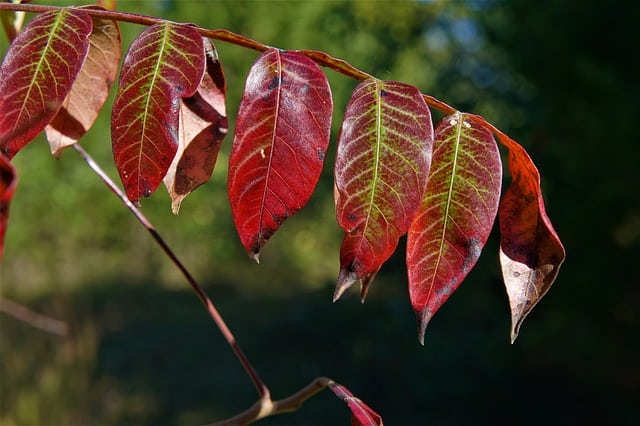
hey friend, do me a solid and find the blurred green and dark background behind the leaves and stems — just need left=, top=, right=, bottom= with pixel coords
left=0, top=0, right=640, bottom=425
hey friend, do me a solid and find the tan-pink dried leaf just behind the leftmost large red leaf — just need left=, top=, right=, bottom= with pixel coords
left=45, top=6, right=121, bottom=157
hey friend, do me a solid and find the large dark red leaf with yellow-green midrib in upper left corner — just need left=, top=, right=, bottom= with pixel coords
left=0, top=9, right=92, bottom=159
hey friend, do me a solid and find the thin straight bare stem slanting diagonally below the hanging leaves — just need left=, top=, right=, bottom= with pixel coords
left=73, top=143, right=271, bottom=400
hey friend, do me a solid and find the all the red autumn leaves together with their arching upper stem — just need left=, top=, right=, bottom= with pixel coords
left=0, top=2, right=565, bottom=424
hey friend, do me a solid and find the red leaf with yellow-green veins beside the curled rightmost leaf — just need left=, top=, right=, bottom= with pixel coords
left=407, top=112, right=502, bottom=344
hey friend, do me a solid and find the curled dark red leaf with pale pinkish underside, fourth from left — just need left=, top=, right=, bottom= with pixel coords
left=164, top=38, right=228, bottom=214
